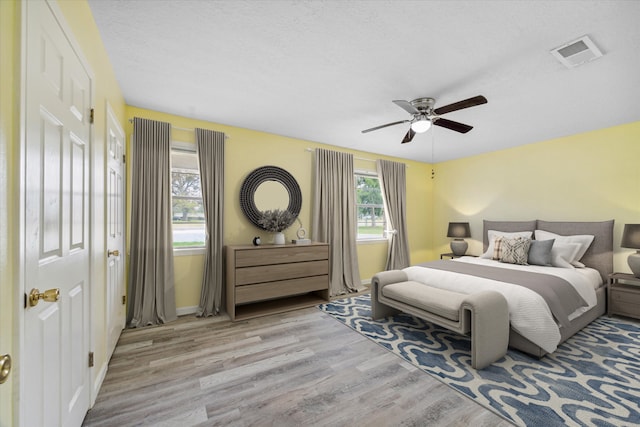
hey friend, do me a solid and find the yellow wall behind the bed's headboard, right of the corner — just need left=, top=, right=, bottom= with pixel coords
left=433, top=122, right=640, bottom=272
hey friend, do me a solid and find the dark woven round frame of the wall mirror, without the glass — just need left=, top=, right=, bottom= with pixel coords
left=240, top=166, right=302, bottom=230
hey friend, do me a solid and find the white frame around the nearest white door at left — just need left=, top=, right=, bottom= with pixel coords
left=17, top=0, right=96, bottom=427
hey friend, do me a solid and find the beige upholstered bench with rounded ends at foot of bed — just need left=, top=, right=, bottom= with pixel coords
left=371, top=270, right=509, bottom=369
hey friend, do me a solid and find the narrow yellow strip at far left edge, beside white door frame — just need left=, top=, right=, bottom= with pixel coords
left=0, top=1, right=20, bottom=427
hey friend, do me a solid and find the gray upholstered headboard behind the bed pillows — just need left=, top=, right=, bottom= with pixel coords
left=482, top=219, right=614, bottom=283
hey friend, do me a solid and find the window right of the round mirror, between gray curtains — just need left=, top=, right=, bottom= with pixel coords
left=355, top=172, right=386, bottom=240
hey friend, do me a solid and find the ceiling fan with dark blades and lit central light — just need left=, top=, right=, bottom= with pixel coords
left=362, top=95, right=487, bottom=144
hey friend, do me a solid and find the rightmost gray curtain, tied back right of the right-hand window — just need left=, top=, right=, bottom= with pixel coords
left=376, top=160, right=410, bottom=270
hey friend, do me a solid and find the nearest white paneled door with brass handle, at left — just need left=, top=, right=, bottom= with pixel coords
left=20, top=1, right=92, bottom=427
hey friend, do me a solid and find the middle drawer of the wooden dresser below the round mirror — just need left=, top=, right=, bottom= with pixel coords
left=236, top=260, right=329, bottom=286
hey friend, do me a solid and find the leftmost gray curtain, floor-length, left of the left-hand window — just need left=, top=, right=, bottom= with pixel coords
left=127, top=117, right=176, bottom=327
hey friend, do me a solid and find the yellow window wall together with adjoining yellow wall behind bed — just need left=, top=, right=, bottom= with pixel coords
left=127, top=107, right=640, bottom=308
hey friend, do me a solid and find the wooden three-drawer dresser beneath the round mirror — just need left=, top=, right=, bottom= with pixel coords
left=225, top=243, right=329, bottom=321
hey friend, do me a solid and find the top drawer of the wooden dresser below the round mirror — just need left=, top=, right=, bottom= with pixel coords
left=235, top=245, right=329, bottom=268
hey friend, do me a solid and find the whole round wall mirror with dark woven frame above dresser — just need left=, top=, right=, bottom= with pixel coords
left=240, top=166, right=302, bottom=230
